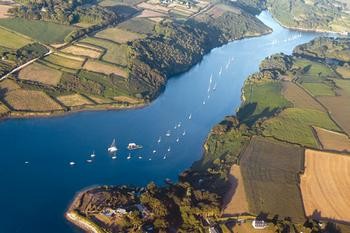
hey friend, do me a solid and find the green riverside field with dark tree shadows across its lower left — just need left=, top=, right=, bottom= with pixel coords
left=237, top=81, right=292, bottom=125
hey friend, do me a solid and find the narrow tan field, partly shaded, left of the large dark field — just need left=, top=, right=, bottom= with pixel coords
left=223, top=164, right=249, bottom=216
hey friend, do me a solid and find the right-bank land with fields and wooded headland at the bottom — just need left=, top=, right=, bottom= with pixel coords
left=67, top=38, right=350, bottom=232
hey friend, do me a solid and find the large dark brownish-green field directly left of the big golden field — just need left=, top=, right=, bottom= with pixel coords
left=240, top=137, right=304, bottom=222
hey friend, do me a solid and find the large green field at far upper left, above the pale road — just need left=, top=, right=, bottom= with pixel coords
left=0, top=18, right=74, bottom=44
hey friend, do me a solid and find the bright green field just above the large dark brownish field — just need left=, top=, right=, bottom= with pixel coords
left=263, top=108, right=340, bottom=148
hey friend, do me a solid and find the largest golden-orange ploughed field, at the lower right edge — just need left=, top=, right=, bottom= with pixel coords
left=300, top=150, right=350, bottom=223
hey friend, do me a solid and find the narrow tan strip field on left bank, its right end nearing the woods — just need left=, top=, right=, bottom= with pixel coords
left=83, top=60, right=128, bottom=78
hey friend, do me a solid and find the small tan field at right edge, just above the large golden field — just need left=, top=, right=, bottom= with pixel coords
left=314, top=127, right=350, bottom=152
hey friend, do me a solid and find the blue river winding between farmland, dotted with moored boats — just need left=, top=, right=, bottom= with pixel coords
left=0, top=13, right=319, bottom=233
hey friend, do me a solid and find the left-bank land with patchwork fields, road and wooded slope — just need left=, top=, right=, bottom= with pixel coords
left=0, top=0, right=271, bottom=117
